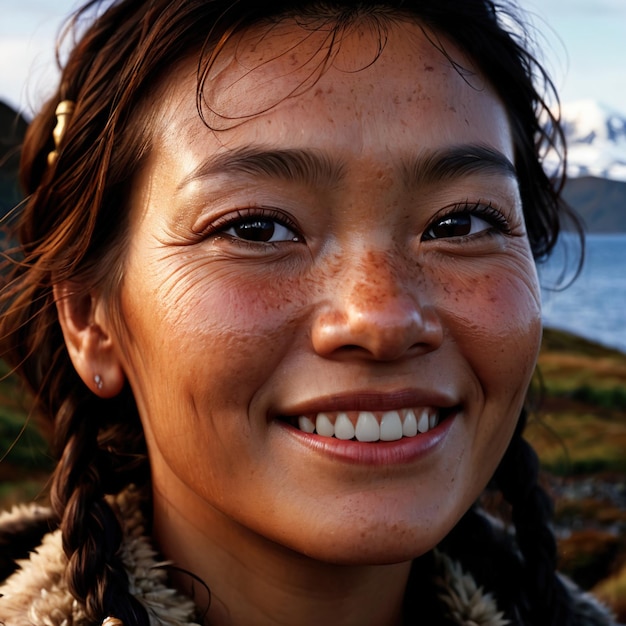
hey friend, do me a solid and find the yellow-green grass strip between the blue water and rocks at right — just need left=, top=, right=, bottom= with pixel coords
left=526, top=330, right=626, bottom=476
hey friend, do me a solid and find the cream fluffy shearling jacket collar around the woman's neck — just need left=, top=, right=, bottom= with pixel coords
left=0, top=491, right=615, bottom=626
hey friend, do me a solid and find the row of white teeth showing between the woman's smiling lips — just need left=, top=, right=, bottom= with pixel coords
left=287, top=407, right=458, bottom=443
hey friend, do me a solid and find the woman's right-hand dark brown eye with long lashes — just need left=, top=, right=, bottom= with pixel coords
left=422, top=204, right=509, bottom=241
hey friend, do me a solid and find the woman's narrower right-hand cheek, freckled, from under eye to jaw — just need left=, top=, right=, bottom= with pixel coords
left=426, top=260, right=541, bottom=497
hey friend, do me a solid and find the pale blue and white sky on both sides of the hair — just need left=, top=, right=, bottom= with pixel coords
left=0, top=0, right=626, bottom=117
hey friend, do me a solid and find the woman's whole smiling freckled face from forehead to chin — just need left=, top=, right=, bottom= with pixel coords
left=109, top=22, right=540, bottom=563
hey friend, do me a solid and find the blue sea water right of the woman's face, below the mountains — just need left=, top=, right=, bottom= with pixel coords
left=539, top=234, right=626, bottom=352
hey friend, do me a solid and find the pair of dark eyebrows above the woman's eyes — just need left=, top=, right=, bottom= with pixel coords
left=178, top=144, right=517, bottom=190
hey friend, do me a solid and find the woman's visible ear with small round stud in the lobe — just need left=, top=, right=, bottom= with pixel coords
left=54, top=281, right=125, bottom=398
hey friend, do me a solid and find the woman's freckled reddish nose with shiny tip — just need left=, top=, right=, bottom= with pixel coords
left=312, top=246, right=443, bottom=361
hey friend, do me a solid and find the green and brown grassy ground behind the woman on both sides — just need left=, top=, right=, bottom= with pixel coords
left=0, top=330, right=626, bottom=621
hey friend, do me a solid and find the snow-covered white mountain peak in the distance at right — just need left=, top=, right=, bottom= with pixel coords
left=561, top=100, right=626, bottom=182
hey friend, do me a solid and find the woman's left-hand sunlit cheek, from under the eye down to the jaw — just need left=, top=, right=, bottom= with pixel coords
left=118, top=263, right=306, bottom=482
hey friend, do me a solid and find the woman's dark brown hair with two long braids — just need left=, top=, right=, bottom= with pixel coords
left=0, top=0, right=580, bottom=626
